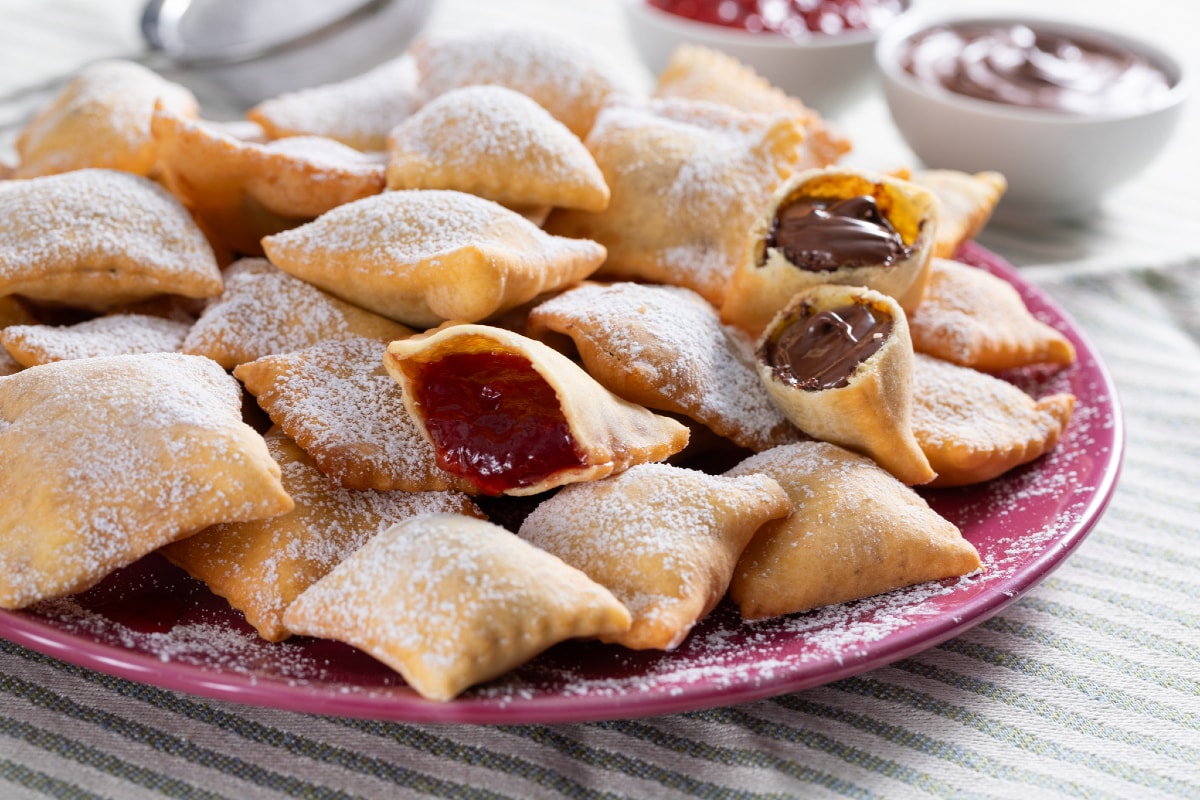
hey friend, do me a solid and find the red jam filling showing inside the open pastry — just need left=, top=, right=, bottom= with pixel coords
left=414, top=353, right=586, bottom=494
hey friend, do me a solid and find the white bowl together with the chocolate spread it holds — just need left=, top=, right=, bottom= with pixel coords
left=875, top=17, right=1190, bottom=222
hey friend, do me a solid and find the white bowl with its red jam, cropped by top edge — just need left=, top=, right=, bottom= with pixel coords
left=624, top=0, right=911, bottom=115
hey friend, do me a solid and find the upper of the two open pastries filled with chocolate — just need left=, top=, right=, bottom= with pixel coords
left=721, top=167, right=938, bottom=335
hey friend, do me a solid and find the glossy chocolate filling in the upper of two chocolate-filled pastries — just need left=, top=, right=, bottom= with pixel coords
left=767, top=194, right=910, bottom=272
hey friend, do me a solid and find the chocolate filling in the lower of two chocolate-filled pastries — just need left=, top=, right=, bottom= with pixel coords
left=758, top=303, right=892, bottom=391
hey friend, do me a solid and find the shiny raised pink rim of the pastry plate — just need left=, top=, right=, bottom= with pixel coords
left=0, top=242, right=1126, bottom=724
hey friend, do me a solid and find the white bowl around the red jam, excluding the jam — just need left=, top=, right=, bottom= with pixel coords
left=622, top=0, right=902, bottom=116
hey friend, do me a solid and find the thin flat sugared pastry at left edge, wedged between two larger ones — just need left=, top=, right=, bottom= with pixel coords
left=0, top=313, right=191, bottom=367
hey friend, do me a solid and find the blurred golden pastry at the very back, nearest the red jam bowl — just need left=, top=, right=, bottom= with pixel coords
left=652, top=44, right=851, bottom=164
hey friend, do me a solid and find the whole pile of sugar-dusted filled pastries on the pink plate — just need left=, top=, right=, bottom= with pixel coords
left=0, top=30, right=1074, bottom=700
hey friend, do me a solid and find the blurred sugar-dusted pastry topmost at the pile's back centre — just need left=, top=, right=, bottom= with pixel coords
left=412, top=29, right=634, bottom=139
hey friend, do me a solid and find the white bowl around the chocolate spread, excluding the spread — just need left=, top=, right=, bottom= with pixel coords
left=875, top=16, right=1190, bottom=221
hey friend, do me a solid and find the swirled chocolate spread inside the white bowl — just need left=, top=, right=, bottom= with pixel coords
left=901, top=23, right=1170, bottom=114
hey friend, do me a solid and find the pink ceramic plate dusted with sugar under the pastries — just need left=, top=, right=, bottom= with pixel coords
left=0, top=246, right=1123, bottom=723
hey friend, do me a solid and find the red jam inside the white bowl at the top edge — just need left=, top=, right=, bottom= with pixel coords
left=647, top=0, right=904, bottom=38
